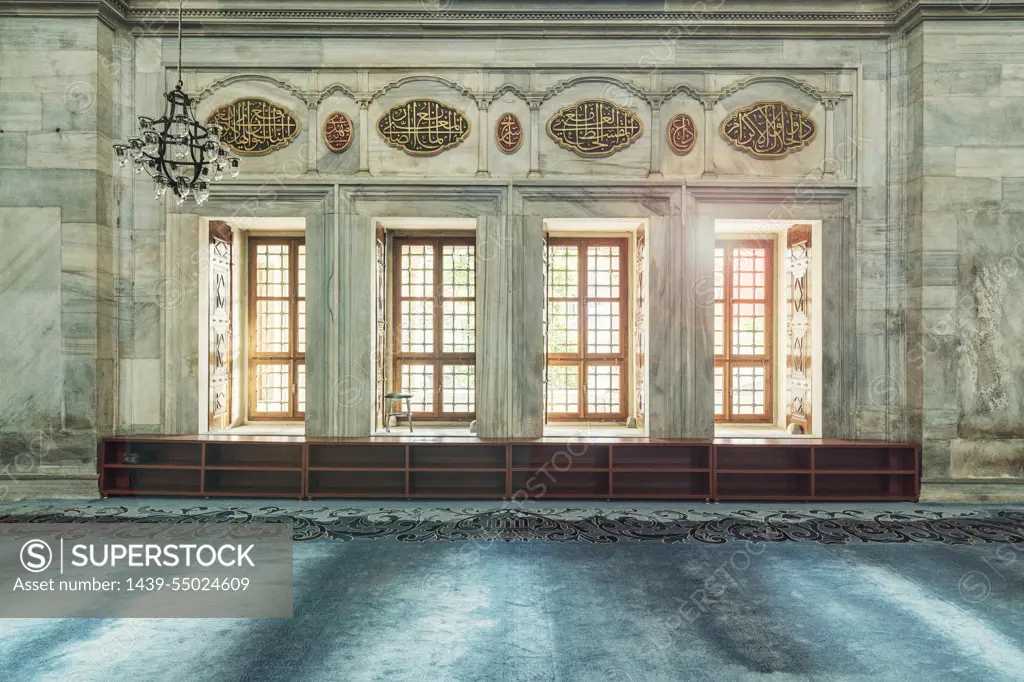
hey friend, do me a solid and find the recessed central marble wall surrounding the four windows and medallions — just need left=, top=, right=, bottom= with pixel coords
left=121, top=38, right=888, bottom=446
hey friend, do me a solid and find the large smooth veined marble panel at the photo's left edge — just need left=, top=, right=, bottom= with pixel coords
left=0, top=208, right=63, bottom=431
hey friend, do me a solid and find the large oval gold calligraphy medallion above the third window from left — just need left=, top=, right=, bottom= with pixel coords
left=548, top=99, right=643, bottom=159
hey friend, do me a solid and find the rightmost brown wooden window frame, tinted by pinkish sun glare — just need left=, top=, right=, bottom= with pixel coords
left=712, top=239, right=775, bottom=424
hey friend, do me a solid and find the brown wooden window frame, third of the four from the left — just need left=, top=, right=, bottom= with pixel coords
left=544, top=236, right=633, bottom=422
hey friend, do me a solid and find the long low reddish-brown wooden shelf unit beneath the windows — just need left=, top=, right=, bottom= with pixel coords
left=98, top=435, right=921, bottom=501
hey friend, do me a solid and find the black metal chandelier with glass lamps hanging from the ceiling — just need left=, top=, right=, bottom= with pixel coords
left=114, top=0, right=239, bottom=206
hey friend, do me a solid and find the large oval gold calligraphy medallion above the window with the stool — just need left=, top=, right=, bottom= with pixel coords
left=377, top=99, right=469, bottom=157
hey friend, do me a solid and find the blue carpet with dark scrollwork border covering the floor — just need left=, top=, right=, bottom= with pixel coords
left=0, top=501, right=1024, bottom=682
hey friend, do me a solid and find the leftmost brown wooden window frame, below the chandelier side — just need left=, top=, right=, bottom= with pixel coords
left=246, top=237, right=308, bottom=422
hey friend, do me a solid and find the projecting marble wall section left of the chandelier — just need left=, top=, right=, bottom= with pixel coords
left=0, top=16, right=118, bottom=498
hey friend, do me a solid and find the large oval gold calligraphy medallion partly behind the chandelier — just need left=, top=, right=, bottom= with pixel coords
left=206, top=97, right=299, bottom=157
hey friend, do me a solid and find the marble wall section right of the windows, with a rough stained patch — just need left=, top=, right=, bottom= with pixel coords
left=906, top=23, right=1024, bottom=489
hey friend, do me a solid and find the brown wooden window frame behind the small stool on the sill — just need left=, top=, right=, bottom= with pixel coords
left=389, top=232, right=479, bottom=422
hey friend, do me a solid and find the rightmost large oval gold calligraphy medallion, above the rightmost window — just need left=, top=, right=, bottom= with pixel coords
left=722, top=101, right=817, bottom=159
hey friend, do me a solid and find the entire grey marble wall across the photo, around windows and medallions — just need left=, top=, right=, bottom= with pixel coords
left=6, top=1, right=1024, bottom=499
